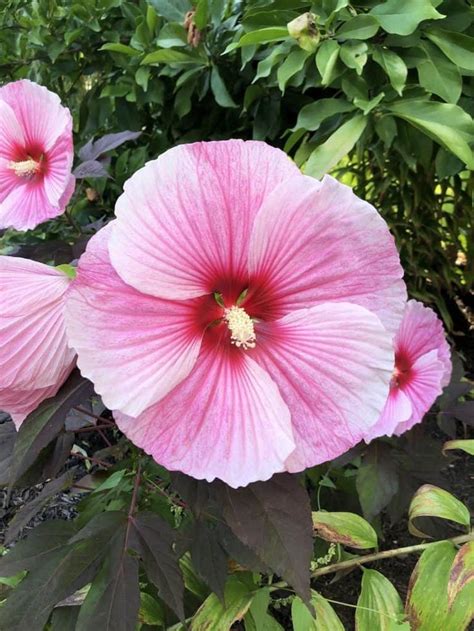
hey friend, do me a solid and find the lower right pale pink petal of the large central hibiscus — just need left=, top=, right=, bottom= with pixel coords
left=249, top=303, right=393, bottom=472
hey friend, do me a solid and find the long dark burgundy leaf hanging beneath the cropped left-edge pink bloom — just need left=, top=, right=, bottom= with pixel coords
left=10, top=369, right=94, bottom=486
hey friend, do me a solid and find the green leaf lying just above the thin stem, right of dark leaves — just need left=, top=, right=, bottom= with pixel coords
left=313, top=511, right=377, bottom=549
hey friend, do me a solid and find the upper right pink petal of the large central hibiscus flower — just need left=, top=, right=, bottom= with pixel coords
left=249, top=176, right=406, bottom=332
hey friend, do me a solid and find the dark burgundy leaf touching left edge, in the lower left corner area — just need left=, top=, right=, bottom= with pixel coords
left=0, top=519, right=75, bottom=576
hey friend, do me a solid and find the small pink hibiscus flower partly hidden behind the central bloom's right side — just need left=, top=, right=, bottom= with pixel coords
left=366, top=300, right=451, bottom=441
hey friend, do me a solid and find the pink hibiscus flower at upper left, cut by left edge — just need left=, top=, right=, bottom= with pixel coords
left=0, top=79, right=75, bottom=230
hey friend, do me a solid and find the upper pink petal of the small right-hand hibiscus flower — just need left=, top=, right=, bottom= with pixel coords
left=395, top=300, right=451, bottom=387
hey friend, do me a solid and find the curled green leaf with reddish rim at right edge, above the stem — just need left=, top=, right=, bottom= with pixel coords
left=408, top=484, right=471, bottom=537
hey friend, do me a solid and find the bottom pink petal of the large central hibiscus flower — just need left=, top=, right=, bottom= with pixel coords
left=115, top=347, right=295, bottom=488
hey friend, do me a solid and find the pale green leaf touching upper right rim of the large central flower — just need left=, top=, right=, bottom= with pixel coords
left=304, top=114, right=367, bottom=179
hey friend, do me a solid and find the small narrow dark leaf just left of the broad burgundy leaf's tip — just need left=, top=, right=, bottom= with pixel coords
left=191, top=519, right=228, bottom=600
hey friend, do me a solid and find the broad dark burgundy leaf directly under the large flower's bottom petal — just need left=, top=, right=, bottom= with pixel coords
left=215, top=473, right=313, bottom=602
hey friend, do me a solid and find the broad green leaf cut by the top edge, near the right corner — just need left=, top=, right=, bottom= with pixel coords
left=369, top=0, right=446, bottom=35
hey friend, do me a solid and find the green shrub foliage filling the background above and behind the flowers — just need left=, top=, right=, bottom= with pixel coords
left=0, top=0, right=474, bottom=330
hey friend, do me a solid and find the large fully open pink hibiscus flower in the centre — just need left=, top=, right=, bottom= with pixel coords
left=66, top=140, right=406, bottom=487
